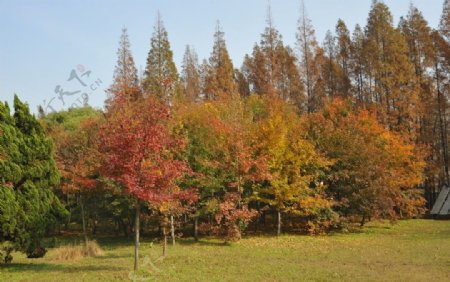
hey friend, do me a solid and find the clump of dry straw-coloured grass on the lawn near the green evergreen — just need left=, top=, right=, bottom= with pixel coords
left=55, top=241, right=103, bottom=261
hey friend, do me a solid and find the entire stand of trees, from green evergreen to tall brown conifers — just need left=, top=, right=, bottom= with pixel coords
left=0, top=0, right=450, bottom=269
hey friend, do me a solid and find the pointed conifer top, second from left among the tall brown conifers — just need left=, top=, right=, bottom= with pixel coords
left=143, top=13, right=179, bottom=101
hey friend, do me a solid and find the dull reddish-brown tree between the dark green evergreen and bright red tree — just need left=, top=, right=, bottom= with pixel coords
left=41, top=107, right=102, bottom=245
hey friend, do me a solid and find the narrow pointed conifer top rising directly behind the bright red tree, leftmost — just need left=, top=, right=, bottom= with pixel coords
left=106, top=27, right=141, bottom=108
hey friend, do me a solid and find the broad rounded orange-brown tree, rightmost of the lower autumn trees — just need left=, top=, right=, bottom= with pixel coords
left=309, top=100, right=424, bottom=224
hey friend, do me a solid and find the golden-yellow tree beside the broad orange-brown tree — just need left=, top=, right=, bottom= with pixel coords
left=249, top=97, right=331, bottom=235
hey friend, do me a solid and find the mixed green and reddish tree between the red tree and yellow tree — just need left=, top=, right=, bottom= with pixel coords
left=176, top=94, right=267, bottom=240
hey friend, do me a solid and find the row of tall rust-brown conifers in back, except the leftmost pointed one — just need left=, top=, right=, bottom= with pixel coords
left=134, top=0, right=450, bottom=208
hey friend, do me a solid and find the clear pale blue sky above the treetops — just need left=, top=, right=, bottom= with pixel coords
left=0, top=0, right=443, bottom=112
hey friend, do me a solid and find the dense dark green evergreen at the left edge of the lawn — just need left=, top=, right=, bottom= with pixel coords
left=0, top=96, right=67, bottom=262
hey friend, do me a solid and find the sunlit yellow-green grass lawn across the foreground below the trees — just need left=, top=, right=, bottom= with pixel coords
left=0, top=220, right=450, bottom=281
